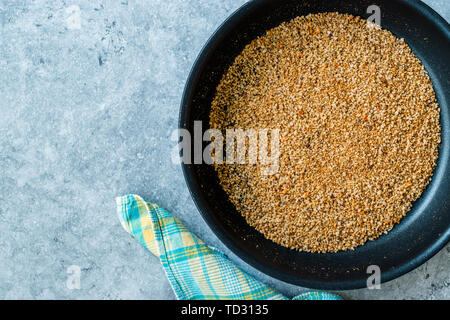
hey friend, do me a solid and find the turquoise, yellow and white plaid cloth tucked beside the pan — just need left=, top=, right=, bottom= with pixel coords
left=117, top=195, right=341, bottom=300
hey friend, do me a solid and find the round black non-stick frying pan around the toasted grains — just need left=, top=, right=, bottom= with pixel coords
left=179, top=0, right=450, bottom=290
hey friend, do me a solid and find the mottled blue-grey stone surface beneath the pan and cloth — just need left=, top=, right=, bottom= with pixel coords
left=0, top=0, right=450, bottom=299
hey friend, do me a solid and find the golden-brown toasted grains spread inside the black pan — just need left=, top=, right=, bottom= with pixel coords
left=210, top=13, right=440, bottom=252
